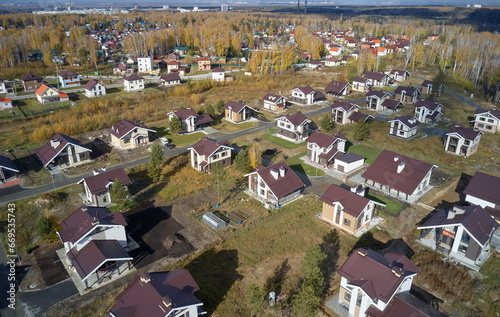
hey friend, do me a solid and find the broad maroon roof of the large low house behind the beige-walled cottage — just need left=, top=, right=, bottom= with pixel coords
left=362, top=150, right=433, bottom=195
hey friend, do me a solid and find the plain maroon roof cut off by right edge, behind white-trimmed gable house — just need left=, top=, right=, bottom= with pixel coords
left=464, top=172, right=500, bottom=205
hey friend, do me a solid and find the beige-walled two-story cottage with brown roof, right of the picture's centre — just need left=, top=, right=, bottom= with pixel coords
left=320, top=184, right=375, bottom=234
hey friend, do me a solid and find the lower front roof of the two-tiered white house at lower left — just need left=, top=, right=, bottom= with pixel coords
left=67, top=240, right=132, bottom=280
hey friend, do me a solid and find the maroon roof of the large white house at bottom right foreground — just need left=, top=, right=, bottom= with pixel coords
left=338, top=249, right=419, bottom=303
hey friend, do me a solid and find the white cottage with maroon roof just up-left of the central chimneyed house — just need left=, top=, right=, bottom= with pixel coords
left=188, top=137, right=233, bottom=173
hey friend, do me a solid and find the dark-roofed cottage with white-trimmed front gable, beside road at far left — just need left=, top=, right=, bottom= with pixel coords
left=36, top=133, right=92, bottom=167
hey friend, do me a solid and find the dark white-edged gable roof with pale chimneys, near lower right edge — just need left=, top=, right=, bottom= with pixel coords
left=417, top=206, right=499, bottom=247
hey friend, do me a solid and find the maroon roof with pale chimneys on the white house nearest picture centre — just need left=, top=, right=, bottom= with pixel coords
left=251, top=161, right=305, bottom=199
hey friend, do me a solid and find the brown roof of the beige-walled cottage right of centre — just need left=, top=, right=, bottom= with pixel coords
left=319, top=184, right=370, bottom=218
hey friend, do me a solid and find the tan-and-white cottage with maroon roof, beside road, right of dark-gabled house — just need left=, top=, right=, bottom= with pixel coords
left=108, top=119, right=156, bottom=149
